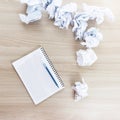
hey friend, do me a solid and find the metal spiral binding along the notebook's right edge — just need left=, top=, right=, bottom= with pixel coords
left=40, top=47, right=64, bottom=87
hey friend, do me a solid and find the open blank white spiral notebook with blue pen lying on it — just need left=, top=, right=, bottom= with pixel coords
left=12, top=47, right=64, bottom=104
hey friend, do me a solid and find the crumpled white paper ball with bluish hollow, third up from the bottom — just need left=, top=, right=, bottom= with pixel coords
left=81, top=27, right=103, bottom=48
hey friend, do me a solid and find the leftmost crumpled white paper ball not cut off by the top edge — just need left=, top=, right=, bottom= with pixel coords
left=54, top=3, right=77, bottom=29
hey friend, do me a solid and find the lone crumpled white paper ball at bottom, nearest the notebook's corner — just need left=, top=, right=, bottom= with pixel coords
left=72, top=78, right=88, bottom=101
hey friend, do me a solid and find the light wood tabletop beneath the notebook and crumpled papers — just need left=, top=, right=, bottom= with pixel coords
left=0, top=0, right=120, bottom=120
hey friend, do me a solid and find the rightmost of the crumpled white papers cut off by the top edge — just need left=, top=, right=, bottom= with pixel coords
left=46, top=0, right=62, bottom=19
